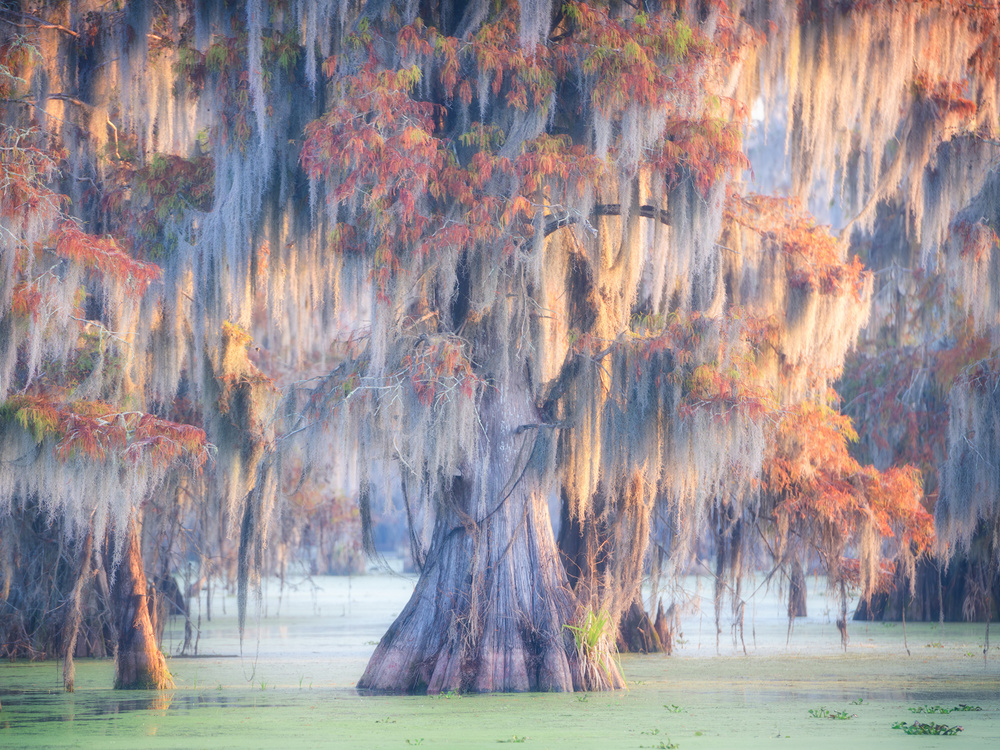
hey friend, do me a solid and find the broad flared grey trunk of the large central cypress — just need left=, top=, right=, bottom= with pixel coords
left=358, top=377, right=624, bottom=693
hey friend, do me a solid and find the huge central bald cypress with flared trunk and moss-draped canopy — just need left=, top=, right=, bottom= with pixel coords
left=0, top=0, right=997, bottom=692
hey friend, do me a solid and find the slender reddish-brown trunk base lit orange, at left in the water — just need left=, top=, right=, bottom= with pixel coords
left=111, top=521, right=174, bottom=690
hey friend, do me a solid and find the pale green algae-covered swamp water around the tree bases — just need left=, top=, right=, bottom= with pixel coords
left=0, top=574, right=1000, bottom=750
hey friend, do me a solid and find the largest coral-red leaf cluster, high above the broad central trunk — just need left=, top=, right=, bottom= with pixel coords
left=300, top=50, right=603, bottom=296
